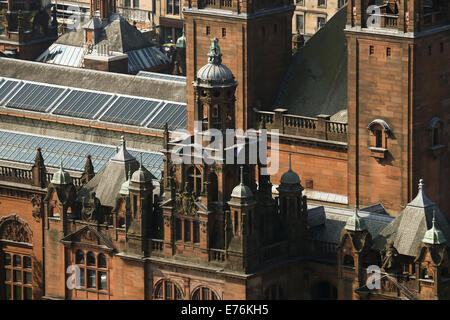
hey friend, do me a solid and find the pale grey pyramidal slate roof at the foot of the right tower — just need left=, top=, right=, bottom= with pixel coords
left=374, top=180, right=450, bottom=257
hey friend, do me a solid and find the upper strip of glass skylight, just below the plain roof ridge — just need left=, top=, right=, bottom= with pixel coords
left=0, top=77, right=187, bottom=130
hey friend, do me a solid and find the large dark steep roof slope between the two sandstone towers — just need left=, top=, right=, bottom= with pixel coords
left=275, top=6, right=347, bottom=122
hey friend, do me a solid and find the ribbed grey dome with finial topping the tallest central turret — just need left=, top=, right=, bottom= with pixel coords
left=194, top=38, right=236, bottom=87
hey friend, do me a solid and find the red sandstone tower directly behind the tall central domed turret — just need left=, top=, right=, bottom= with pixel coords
left=183, top=0, right=294, bottom=130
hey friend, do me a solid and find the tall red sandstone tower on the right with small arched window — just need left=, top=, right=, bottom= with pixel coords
left=345, top=0, right=450, bottom=214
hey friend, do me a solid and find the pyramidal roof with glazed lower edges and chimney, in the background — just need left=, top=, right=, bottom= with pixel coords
left=36, top=1, right=172, bottom=74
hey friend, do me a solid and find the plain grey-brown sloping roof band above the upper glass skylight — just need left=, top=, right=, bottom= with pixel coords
left=0, top=58, right=186, bottom=103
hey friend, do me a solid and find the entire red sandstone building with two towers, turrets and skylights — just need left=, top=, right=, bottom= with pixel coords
left=0, top=0, right=450, bottom=300
